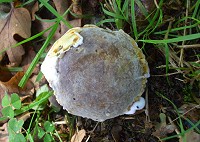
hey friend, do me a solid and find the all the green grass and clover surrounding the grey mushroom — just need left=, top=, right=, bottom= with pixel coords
left=0, top=0, right=200, bottom=141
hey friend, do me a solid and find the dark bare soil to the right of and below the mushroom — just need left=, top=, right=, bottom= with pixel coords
left=66, top=1, right=198, bottom=142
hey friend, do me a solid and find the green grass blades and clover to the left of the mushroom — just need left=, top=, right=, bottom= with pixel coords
left=0, top=0, right=75, bottom=142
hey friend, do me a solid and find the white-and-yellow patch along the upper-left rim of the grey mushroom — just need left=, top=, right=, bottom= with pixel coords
left=41, top=27, right=83, bottom=88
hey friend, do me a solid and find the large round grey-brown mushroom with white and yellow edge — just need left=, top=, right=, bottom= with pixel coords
left=41, top=25, right=150, bottom=122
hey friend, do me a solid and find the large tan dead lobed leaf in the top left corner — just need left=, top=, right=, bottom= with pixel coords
left=0, top=2, right=31, bottom=66
